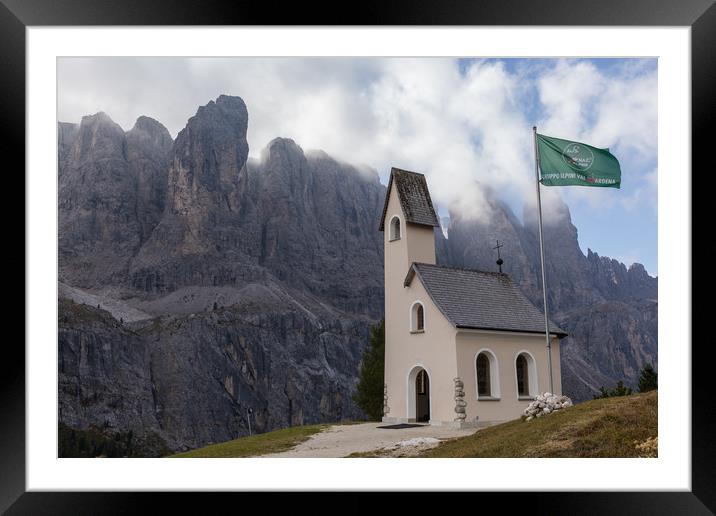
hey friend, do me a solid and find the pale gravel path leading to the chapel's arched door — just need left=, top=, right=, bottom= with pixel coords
left=262, top=423, right=476, bottom=457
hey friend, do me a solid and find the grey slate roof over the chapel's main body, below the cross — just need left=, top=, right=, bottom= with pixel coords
left=405, top=263, right=567, bottom=338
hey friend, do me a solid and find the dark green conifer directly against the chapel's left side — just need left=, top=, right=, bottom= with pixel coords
left=353, top=320, right=385, bottom=421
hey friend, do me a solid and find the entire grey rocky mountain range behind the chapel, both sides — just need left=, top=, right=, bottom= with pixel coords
left=58, top=95, right=657, bottom=456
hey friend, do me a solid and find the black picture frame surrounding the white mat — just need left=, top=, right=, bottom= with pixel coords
left=0, top=0, right=716, bottom=514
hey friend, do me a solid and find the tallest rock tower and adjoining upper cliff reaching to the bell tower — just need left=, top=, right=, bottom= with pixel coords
left=128, top=96, right=385, bottom=317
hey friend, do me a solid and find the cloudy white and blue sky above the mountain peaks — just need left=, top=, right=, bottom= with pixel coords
left=57, top=57, right=658, bottom=276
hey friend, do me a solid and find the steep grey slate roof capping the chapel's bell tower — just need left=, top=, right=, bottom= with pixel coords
left=379, top=167, right=440, bottom=231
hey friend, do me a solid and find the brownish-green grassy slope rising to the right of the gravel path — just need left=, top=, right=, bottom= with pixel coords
left=421, top=391, right=658, bottom=458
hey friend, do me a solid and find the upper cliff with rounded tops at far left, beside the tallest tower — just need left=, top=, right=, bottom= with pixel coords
left=58, top=113, right=171, bottom=288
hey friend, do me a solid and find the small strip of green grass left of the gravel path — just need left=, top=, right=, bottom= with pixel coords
left=170, top=424, right=331, bottom=458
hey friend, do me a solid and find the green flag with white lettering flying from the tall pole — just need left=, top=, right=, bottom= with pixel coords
left=537, top=133, right=622, bottom=188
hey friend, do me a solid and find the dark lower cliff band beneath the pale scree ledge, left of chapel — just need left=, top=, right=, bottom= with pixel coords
left=58, top=299, right=368, bottom=456
